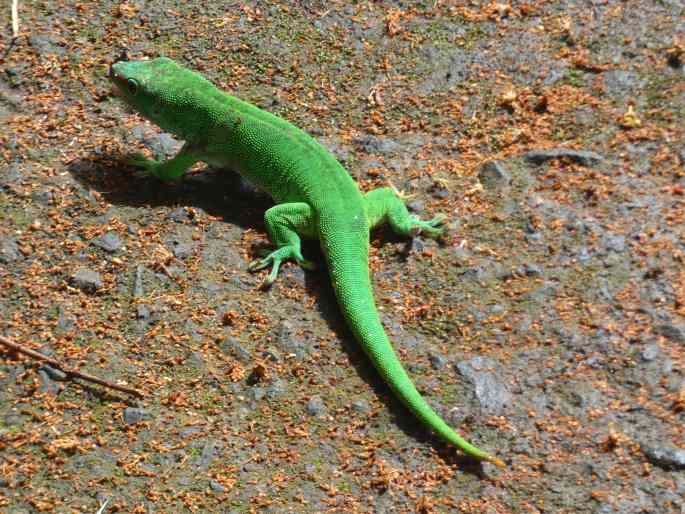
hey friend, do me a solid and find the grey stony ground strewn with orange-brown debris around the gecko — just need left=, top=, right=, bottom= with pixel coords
left=0, top=0, right=685, bottom=514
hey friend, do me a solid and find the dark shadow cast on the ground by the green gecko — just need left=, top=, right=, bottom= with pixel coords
left=69, top=156, right=483, bottom=476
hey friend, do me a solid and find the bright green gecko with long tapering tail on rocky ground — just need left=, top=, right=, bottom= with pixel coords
left=109, top=58, right=504, bottom=466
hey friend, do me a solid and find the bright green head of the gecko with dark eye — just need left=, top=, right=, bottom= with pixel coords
left=109, top=57, right=205, bottom=134
